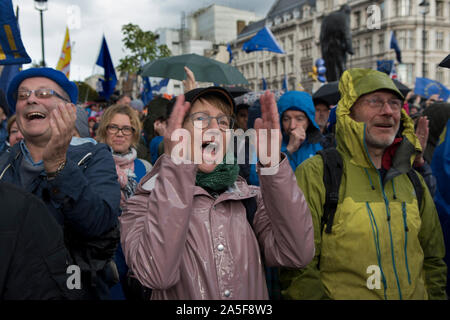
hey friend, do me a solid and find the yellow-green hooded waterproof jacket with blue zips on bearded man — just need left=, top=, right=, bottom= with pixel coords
left=281, top=69, right=447, bottom=300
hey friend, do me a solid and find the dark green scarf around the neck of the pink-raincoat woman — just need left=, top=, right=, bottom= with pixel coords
left=195, top=158, right=239, bottom=191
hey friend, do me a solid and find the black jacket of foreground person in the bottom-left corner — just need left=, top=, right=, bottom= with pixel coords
left=0, top=182, right=72, bottom=300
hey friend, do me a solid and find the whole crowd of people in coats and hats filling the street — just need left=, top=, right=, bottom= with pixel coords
left=0, top=63, right=450, bottom=300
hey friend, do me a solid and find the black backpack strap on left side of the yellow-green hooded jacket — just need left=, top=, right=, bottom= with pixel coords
left=317, top=148, right=343, bottom=233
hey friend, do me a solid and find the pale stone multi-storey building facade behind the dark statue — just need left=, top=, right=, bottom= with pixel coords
left=232, top=0, right=450, bottom=92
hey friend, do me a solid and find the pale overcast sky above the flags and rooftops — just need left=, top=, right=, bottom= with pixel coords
left=13, top=0, right=276, bottom=80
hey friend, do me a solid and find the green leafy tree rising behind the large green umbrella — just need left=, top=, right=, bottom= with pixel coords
left=117, top=23, right=171, bottom=73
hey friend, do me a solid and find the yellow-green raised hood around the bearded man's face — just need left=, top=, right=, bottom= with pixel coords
left=336, top=68, right=421, bottom=173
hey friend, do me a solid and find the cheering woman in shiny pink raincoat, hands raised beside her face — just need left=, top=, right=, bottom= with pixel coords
left=120, top=87, right=314, bottom=300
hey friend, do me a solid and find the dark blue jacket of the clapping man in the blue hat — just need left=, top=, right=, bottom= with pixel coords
left=0, top=143, right=120, bottom=238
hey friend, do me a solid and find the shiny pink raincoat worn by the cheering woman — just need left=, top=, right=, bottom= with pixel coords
left=120, top=155, right=314, bottom=300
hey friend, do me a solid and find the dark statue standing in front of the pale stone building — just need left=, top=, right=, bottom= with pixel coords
left=320, top=4, right=353, bottom=82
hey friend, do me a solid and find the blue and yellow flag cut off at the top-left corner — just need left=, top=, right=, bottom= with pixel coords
left=0, top=0, right=31, bottom=64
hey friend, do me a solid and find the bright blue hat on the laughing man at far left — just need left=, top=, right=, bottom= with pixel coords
left=6, top=68, right=78, bottom=114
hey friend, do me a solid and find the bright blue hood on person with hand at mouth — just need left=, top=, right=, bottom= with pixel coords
left=277, top=91, right=320, bottom=142
